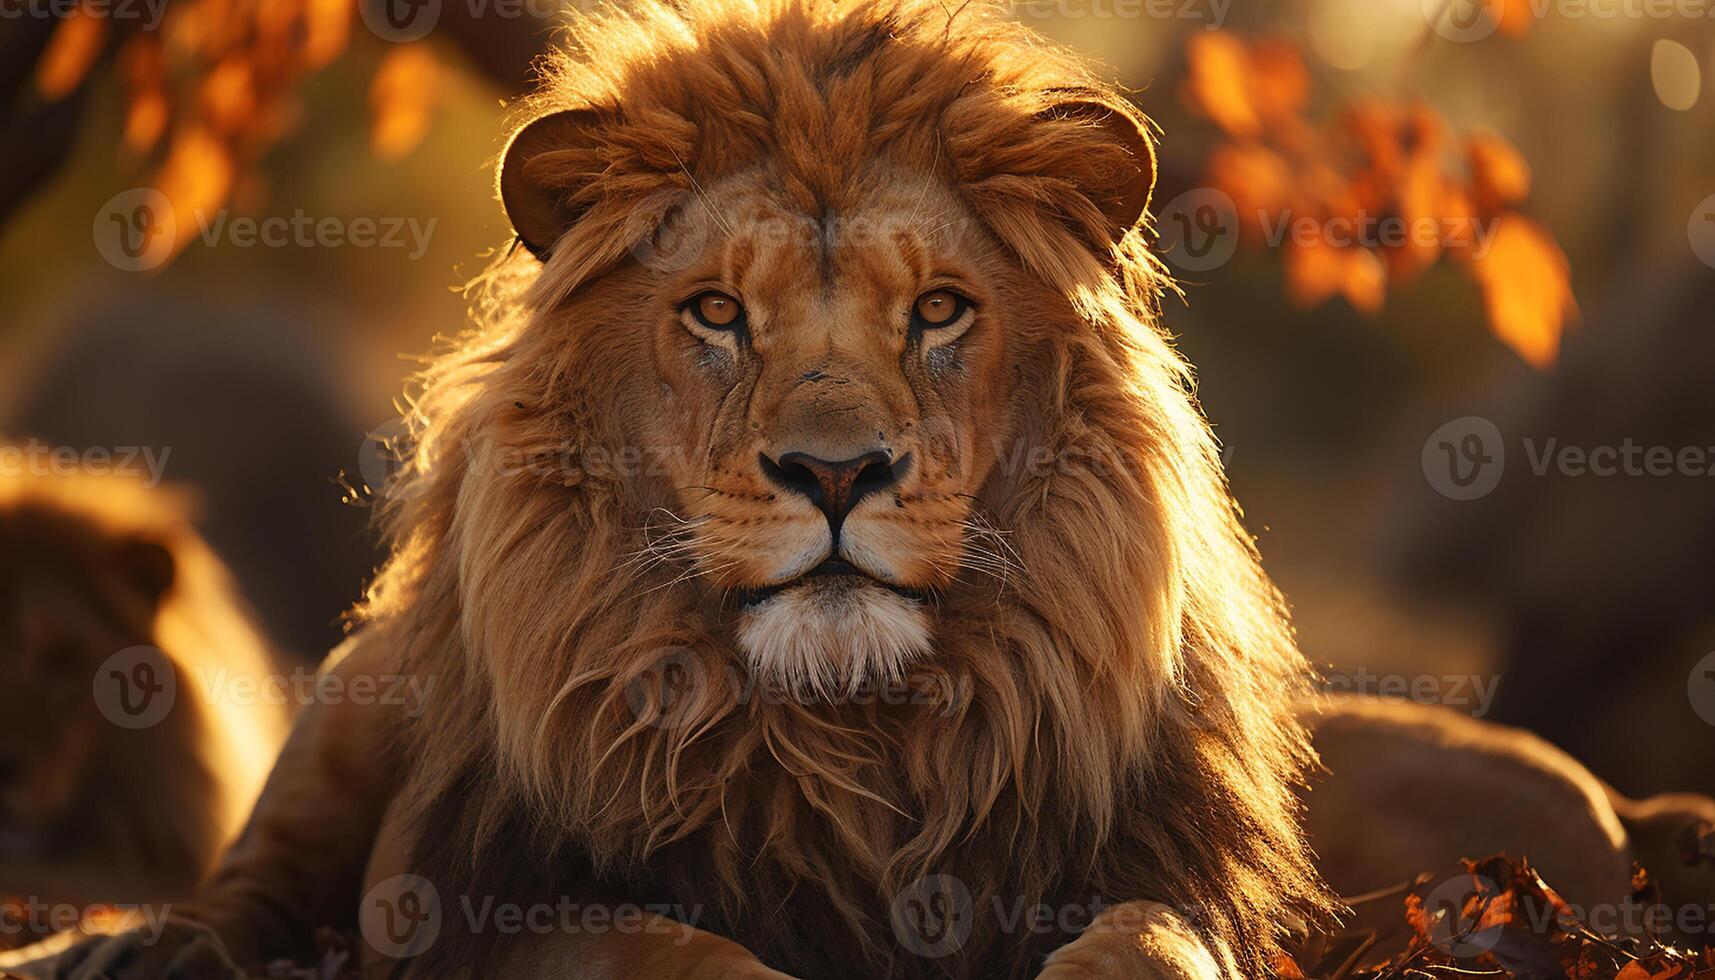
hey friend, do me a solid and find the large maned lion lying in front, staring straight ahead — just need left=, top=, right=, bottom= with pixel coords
left=23, top=0, right=1715, bottom=980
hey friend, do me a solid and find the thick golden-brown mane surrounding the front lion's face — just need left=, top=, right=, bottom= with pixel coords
left=364, top=0, right=1326, bottom=977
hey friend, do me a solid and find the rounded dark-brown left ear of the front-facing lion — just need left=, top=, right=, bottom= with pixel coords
left=501, top=108, right=602, bottom=259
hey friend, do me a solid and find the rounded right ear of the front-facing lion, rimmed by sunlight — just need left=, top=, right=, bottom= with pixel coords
left=1041, top=91, right=1156, bottom=240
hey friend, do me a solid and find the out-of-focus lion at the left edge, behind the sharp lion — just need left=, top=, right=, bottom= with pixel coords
left=0, top=459, right=286, bottom=904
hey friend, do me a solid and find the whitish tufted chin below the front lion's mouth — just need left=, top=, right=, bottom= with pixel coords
left=737, top=575, right=931, bottom=700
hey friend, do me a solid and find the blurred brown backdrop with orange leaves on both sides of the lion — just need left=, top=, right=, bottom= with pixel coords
left=0, top=0, right=1715, bottom=793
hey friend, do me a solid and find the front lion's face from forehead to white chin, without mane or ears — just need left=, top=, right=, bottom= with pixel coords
left=607, top=170, right=1017, bottom=693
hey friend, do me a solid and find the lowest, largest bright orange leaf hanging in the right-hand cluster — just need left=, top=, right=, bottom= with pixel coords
left=1471, top=213, right=1578, bottom=367
